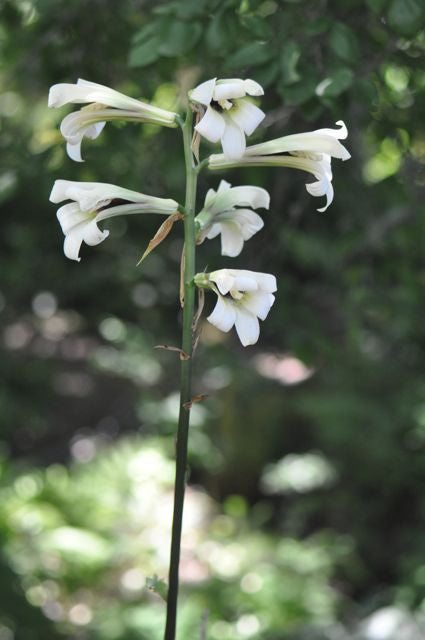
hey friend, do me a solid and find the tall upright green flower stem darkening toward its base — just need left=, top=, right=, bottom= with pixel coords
left=164, top=107, right=197, bottom=640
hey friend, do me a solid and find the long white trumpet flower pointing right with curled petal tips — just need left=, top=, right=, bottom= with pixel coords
left=208, top=120, right=351, bottom=211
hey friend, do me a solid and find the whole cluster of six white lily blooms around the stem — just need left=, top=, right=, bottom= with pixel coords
left=49, top=78, right=350, bottom=346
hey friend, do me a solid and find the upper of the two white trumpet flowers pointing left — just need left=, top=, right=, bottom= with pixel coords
left=48, top=78, right=177, bottom=162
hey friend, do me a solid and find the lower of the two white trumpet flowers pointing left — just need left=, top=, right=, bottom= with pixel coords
left=49, top=180, right=178, bottom=262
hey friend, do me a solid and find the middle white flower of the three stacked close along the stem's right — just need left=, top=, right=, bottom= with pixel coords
left=195, top=180, right=270, bottom=258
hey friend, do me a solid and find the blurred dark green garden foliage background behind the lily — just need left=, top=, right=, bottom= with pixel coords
left=0, top=0, right=425, bottom=640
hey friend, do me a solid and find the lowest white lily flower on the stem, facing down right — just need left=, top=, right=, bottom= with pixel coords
left=195, top=269, right=277, bottom=347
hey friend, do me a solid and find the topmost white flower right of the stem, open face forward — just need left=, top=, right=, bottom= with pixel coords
left=189, top=78, right=265, bottom=159
